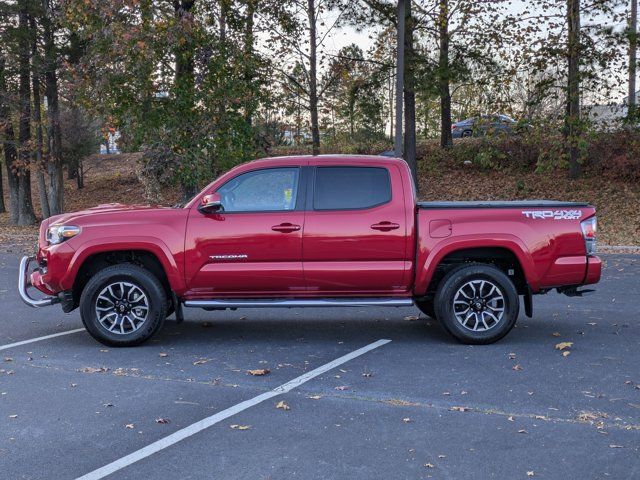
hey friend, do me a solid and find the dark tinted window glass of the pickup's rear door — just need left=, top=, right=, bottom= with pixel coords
left=312, top=167, right=391, bottom=210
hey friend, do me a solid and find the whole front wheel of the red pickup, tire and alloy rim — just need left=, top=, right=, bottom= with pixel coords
left=80, top=264, right=169, bottom=347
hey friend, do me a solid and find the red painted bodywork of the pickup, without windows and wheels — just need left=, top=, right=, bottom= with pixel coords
left=31, top=156, right=601, bottom=299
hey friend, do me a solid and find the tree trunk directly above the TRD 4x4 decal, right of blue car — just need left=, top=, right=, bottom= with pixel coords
left=564, top=0, right=581, bottom=179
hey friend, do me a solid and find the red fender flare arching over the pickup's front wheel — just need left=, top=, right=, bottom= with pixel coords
left=61, top=236, right=185, bottom=294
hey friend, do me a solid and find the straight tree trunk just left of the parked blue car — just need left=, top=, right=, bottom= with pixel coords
left=438, top=0, right=453, bottom=148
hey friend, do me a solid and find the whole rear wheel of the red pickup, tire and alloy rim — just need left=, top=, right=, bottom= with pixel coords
left=435, top=264, right=520, bottom=345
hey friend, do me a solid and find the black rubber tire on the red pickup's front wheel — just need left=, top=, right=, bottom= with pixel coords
left=80, top=263, right=170, bottom=347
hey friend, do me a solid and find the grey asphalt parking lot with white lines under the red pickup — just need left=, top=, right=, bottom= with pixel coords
left=0, top=254, right=640, bottom=479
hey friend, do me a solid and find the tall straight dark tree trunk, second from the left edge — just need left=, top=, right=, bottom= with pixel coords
left=18, top=0, right=36, bottom=225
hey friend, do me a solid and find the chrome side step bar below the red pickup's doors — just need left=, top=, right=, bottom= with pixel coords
left=184, top=298, right=413, bottom=309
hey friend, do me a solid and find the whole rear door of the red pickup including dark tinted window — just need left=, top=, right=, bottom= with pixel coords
left=303, top=160, right=410, bottom=296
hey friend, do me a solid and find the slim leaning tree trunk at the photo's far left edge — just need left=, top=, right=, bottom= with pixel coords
left=0, top=52, right=18, bottom=219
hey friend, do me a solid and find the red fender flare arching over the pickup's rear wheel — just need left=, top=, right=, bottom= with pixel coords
left=414, top=234, right=538, bottom=296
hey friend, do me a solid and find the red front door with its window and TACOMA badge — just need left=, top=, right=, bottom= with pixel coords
left=185, top=166, right=305, bottom=298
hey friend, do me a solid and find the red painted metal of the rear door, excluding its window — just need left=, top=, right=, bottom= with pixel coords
left=303, top=158, right=413, bottom=296
